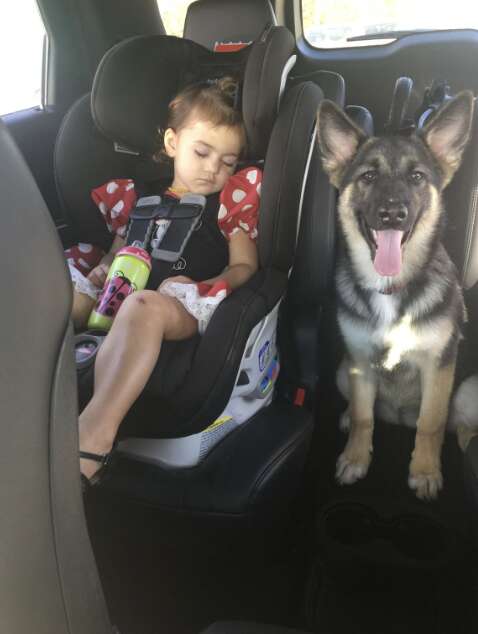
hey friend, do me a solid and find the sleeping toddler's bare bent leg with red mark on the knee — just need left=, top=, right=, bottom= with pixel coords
left=80, top=291, right=197, bottom=478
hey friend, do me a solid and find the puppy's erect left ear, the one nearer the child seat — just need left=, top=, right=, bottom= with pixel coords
left=317, top=99, right=365, bottom=187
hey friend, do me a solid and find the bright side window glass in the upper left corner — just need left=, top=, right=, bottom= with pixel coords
left=0, top=0, right=45, bottom=115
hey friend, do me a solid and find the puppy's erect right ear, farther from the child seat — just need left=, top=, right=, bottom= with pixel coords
left=421, top=90, right=473, bottom=184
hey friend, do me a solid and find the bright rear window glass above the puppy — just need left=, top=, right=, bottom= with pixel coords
left=302, top=0, right=478, bottom=48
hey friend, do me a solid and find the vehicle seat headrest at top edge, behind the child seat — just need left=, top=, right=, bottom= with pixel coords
left=184, top=0, right=277, bottom=50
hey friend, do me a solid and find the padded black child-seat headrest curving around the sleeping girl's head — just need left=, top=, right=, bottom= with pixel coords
left=91, top=27, right=295, bottom=158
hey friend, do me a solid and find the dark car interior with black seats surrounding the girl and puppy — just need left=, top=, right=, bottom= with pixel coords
left=0, top=0, right=478, bottom=634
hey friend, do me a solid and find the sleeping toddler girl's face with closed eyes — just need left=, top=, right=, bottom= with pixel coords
left=164, top=117, right=246, bottom=196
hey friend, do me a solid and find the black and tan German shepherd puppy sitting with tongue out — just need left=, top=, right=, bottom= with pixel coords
left=318, top=92, right=473, bottom=499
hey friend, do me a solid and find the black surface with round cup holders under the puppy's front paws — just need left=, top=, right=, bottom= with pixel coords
left=305, top=380, right=476, bottom=634
